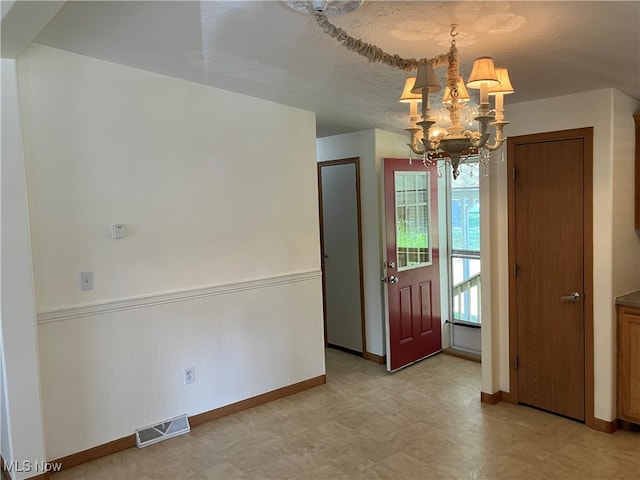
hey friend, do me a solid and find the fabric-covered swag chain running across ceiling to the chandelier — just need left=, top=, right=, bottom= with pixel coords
left=313, top=11, right=449, bottom=72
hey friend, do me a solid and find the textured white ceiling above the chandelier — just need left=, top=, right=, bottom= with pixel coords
left=23, top=0, right=640, bottom=136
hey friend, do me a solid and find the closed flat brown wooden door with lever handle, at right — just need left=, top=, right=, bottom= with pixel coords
left=511, top=138, right=585, bottom=420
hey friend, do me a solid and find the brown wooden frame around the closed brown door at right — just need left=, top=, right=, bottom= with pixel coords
left=502, top=127, right=602, bottom=430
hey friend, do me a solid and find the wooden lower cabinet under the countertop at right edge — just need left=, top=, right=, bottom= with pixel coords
left=617, top=305, right=640, bottom=424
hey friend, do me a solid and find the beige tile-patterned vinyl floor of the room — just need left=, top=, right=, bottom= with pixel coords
left=52, top=349, right=640, bottom=480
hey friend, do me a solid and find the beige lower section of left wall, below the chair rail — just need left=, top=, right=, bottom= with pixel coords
left=38, top=272, right=325, bottom=460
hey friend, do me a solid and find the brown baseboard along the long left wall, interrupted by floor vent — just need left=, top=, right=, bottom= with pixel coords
left=50, top=375, right=327, bottom=472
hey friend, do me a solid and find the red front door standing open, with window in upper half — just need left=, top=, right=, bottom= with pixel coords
left=384, top=158, right=442, bottom=371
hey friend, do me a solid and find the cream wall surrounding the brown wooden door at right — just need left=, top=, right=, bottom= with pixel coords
left=483, top=89, right=640, bottom=421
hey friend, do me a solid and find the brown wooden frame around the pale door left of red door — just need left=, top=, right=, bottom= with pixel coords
left=317, top=157, right=364, bottom=360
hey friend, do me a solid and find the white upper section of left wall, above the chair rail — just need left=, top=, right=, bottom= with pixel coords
left=20, top=46, right=319, bottom=311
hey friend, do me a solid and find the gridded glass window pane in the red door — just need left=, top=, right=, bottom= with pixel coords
left=394, top=170, right=431, bottom=271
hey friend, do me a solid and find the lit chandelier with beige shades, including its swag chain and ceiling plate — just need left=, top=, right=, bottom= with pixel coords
left=284, top=0, right=514, bottom=179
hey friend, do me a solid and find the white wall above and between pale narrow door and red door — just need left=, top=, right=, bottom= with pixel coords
left=317, top=129, right=408, bottom=355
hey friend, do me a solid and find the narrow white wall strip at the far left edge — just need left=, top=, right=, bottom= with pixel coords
left=0, top=59, right=46, bottom=479
